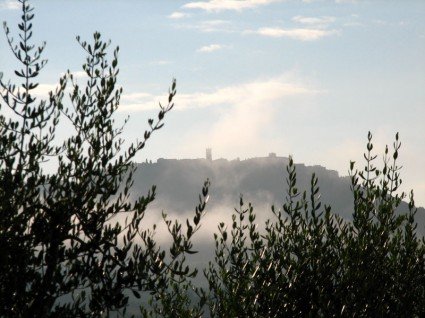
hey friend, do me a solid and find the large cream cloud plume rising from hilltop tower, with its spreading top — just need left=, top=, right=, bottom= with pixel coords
left=176, top=75, right=322, bottom=156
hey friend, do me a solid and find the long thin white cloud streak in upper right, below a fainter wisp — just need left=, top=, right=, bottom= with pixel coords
left=248, top=28, right=339, bottom=41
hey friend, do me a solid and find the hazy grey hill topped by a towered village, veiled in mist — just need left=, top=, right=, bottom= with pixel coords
left=132, top=153, right=425, bottom=238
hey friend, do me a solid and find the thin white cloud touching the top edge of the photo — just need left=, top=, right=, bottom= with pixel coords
left=183, top=0, right=281, bottom=12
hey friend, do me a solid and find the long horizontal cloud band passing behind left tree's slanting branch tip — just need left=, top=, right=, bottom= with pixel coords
left=119, top=76, right=321, bottom=111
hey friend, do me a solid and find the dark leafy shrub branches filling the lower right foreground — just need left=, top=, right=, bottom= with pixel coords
left=205, top=133, right=425, bottom=317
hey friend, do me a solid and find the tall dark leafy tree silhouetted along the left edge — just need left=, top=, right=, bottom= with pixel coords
left=0, top=0, right=209, bottom=317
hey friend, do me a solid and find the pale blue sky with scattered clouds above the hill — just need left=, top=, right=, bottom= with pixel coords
left=0, top=0, right=425, bottom=206
